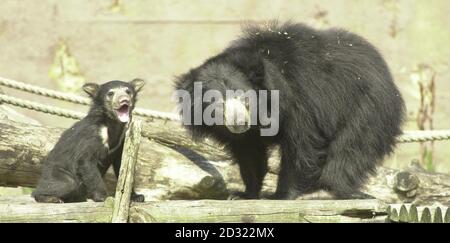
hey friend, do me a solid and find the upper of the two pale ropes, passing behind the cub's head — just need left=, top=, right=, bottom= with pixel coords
left=0, top=77, right=180, bottom=121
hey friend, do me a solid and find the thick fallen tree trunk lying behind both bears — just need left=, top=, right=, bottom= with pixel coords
left=0, top=117, right=450, bottom=205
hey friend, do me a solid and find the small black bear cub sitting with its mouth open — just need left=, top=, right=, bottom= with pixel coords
left=32, top=79, right=144, bottom=203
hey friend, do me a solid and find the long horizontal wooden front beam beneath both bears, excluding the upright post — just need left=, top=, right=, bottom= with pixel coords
left=0, top=196, right=388, bottom=223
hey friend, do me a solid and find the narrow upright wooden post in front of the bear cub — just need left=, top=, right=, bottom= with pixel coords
left=112, top=120, right=142, bottom=223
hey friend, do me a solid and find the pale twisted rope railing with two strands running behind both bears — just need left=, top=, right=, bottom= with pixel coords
left=0, top=78, right=450, bottom=143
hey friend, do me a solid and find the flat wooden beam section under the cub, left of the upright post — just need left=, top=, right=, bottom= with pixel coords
left=0, top=196, right=113, bottom=223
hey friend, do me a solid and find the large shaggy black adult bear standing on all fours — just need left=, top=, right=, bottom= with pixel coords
left=175, top=23, right=405, bottom=199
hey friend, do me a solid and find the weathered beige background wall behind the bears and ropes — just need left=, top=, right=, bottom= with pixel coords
left=0, top=0, right=450, bottom=172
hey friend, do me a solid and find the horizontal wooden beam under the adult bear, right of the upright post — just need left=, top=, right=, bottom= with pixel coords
left=129, top=200, right=387, bottom=223
